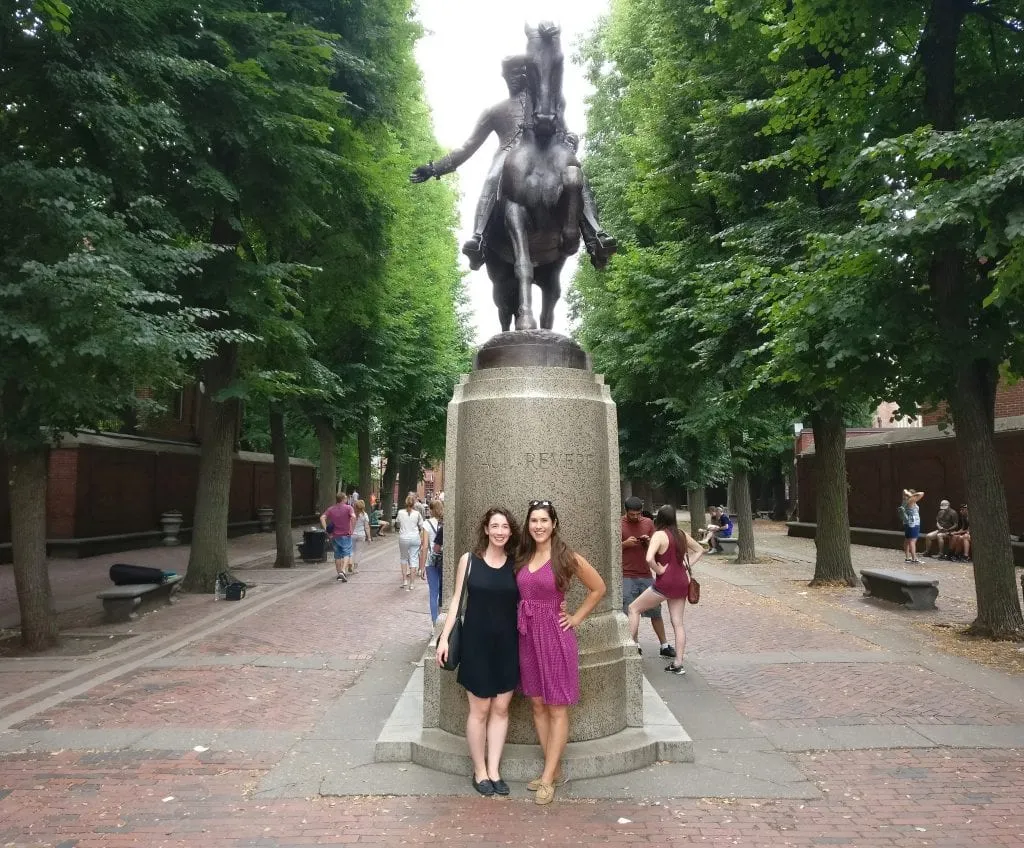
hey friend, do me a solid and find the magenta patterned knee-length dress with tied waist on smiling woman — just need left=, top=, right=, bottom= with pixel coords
left=515, top=560, right=580, bottom=706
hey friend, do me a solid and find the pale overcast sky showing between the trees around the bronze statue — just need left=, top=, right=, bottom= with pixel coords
left=416, top=0, right=608, bottom=342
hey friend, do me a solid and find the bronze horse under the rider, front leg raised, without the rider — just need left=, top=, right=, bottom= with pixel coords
left=483, top=23, right=598, bottom=331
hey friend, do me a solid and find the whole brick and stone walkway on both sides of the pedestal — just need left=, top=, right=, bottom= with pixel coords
left=0, top=537, right=1024, bottom=848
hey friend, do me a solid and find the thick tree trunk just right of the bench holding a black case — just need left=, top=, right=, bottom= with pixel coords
left=182, top=345, right=241, bottom=592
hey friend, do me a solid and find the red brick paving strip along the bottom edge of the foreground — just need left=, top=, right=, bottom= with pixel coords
left=0, top=750, right=1024, bottom=848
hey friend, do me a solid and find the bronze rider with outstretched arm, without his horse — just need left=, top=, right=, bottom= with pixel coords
left=410, top=55, right=615, bottom=270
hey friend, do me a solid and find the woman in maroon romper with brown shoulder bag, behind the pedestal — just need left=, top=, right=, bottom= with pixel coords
left=630, top=504, right=705, bottom=675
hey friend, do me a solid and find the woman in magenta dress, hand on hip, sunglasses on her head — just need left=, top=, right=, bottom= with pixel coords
left=515, top=501, right=605, bottom=804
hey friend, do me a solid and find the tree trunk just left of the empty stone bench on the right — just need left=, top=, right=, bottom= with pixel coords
left=811, top=406, right=857, bottom=586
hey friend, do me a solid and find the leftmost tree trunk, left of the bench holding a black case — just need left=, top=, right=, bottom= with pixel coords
left=7, top=449, right=57, bottom=650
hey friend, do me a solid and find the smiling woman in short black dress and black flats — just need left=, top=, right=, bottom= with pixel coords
left=437, top=507, right=519, bottom=795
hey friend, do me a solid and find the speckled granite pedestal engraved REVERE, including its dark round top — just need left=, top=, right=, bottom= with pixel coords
left=377, top=331, right=692, bottom=778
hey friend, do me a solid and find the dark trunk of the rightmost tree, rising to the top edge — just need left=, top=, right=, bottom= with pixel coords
left=920, top=0, right=1024, bottom=639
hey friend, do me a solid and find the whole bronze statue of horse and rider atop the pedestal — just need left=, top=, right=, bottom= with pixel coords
left=410, top=24, right=615, bottom=331
